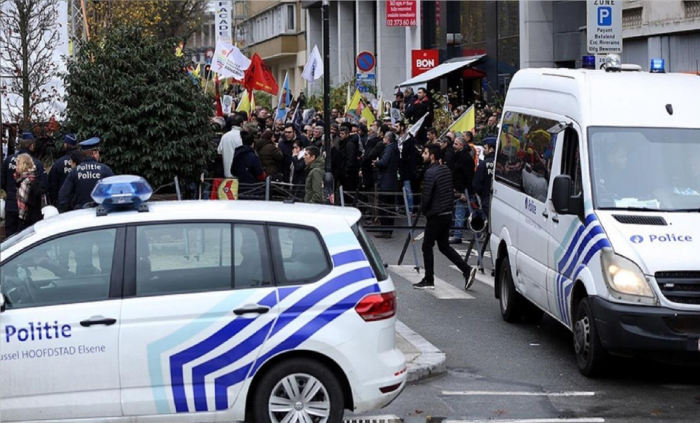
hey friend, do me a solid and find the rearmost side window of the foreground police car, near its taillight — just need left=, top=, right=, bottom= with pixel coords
left=269, top=225, right=331, bottom=285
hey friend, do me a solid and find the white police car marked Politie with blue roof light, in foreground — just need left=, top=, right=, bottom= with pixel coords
left=0, top=176, right=407, bottom=422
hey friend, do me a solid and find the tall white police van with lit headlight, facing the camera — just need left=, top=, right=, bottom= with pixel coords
left=490, top=56, right=700, bottom=376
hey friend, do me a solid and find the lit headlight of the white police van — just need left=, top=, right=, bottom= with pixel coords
left=601, top=250, right=656, bottom=304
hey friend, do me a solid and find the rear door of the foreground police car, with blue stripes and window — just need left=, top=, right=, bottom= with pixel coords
left=120, top=222, right=277, bottom=420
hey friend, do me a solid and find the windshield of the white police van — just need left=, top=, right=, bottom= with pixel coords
left=588, top=127, right=700, bottom=212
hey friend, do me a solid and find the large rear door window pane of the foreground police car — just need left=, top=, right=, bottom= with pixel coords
left=136, top=223, right=232, bottom=297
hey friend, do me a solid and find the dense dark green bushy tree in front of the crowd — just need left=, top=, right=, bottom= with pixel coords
left=65, top=26, right=216, bottom=187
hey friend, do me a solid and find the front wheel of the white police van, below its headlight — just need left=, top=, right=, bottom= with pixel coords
left=574, top=297, right=609, bottom=377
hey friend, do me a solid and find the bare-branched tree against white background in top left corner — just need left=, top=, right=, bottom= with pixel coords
left=0, top=0, right=60, bottom=135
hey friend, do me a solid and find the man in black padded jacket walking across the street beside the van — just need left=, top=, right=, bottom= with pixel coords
left=413, top=144, right=476, bottom=289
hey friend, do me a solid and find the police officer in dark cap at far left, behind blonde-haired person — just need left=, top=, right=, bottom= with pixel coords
left=0, top=132, right=46, bottom=237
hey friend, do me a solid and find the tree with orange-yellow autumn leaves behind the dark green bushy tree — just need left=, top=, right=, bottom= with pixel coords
left=88, top=0, right=209, bottom=41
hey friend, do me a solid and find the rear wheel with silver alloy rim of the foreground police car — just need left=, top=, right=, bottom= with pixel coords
left=252, top=358, right=344, bottom=423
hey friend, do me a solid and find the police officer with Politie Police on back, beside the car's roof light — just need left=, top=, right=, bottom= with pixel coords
left=58, top=137, right=114, bottom=213
